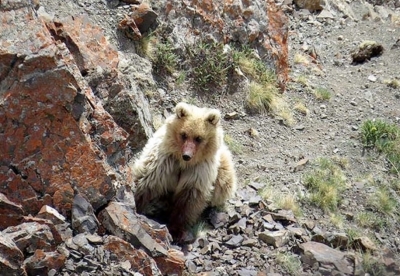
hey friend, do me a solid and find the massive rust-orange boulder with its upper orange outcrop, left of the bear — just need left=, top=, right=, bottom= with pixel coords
left=0, top=5, right=127, bottom=218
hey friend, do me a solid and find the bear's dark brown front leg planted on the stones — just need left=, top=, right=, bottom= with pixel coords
left=168, top=188, right=207, bottom=242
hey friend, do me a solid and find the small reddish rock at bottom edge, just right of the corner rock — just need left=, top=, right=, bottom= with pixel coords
left=24, top=249, right=66, bottom=275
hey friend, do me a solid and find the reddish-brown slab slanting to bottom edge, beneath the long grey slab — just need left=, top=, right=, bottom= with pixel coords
left=104, top=236, right=163, bottom=276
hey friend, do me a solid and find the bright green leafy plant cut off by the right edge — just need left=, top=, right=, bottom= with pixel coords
left=361, top=120, right=400, bottom=175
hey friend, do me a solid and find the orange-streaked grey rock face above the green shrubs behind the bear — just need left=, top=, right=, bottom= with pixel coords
left=155, top=0, right=288, bottom=91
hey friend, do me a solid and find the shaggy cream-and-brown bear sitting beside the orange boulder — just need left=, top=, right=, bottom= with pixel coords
left=132, top=102, right=237, bottom=242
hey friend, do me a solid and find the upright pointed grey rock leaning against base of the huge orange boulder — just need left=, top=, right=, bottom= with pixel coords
left=71, top=194, right=99, bottom=234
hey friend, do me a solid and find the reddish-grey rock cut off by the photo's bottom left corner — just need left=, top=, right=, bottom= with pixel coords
left=0, top=234, right=26, bottom=275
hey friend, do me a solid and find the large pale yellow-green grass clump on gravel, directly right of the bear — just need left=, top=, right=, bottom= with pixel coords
left=304, top=158, right=346, bottom=211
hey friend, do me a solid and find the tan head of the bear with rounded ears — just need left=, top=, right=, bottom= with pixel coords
left=166, top=103, right=223, bottom=165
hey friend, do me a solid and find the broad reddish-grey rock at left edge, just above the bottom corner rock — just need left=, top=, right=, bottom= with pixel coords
left=2, top=222, right=60, bottom=254
